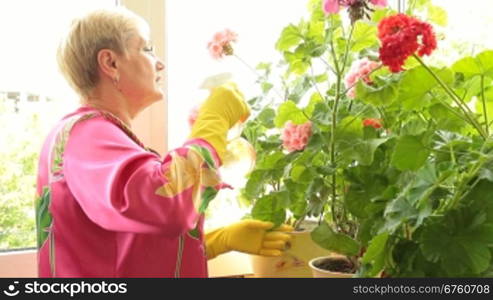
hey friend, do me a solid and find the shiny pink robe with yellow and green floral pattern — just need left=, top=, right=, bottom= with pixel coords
left=36, top=107, right=222, bottom=277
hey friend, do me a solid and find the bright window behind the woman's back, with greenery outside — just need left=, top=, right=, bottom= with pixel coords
left=0, top=0, right=116, bottom=250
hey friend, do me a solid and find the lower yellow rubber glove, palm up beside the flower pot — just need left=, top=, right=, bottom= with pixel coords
left=205, top=220, right=293, bottom=259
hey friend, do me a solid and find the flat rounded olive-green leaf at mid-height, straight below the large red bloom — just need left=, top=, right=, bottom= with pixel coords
left=392, top=135, right=430, bottom=171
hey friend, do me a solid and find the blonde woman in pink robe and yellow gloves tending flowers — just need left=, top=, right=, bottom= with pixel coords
left=36, top=8, right=291, bottom=277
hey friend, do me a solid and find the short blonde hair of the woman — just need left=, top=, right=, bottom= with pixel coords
left=57, top=7, right=149, bottom=97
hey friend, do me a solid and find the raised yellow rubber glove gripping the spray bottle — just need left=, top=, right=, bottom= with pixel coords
left=190, top=82, right=250, bottom=161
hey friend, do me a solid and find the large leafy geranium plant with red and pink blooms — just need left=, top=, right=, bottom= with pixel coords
left=238, top=0, right=493, bottom=277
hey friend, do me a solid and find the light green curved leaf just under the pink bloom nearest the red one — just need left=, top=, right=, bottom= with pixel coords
left=356, top=80, right=398, bottom=106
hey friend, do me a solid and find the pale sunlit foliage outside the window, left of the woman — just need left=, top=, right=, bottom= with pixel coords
left=0, top=95, right=43, bottom=249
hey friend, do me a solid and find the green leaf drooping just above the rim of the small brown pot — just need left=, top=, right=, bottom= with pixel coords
left=311, top=222, right=360, bottom=256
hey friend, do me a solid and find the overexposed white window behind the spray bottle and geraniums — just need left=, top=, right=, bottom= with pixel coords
left=167, top=0, right=493, bottom=227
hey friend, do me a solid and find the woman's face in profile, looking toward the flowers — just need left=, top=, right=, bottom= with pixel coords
left=118, top=27, right=164, bottom=112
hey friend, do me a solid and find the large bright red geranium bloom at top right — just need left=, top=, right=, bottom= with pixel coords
left=378, top=14, right=437, bottom=73
